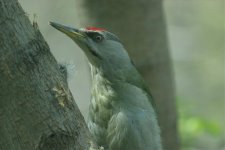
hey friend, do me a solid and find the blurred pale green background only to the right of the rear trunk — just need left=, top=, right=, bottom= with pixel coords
left=165, top=0, right=225, bottom=150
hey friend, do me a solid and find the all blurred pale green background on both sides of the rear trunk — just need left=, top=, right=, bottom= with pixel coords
left=19, top=0, right=225, bottom=150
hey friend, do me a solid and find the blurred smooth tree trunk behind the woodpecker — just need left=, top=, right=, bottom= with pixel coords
left=81, top=0, right=179, bottom=150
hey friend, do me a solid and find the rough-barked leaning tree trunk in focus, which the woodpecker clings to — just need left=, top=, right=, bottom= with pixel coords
left=0, top=0, right=89, bottom=150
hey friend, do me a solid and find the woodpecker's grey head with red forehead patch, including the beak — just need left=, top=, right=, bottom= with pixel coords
left=50, top=22, right=131, bottom=75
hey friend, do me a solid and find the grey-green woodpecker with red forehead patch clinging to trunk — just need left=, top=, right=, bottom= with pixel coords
left=50, top=22, right=162, bottom=150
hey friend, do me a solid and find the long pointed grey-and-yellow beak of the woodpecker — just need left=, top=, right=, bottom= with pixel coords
left=49, top=21, right=86, bottom=39
